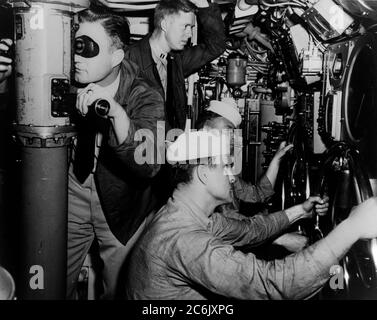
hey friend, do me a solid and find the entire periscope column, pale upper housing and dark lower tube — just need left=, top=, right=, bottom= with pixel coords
left=9, top=0, right=89, bottom=300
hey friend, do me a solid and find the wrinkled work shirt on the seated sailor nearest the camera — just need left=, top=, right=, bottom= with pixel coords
left=126, top=185, right=337, bottom=300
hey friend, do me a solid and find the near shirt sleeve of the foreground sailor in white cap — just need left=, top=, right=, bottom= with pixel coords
left=171, top=232, right=338, bottom=299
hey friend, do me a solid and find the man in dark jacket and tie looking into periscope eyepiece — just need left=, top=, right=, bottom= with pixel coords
left=67, top=7, right=164, bottom=298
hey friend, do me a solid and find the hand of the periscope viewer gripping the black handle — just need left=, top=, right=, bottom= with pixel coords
left=76, top=83, right=125, bottom=119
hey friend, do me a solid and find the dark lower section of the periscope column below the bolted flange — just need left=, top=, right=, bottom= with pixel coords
left=17, top=147, right=67, bottom=300
